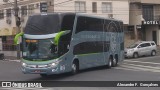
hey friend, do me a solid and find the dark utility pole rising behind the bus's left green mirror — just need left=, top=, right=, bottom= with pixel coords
left=3, top=0, right=21, bottom=59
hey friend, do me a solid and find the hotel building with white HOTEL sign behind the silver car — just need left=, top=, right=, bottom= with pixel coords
left=128, top=0, right=160, bottom=45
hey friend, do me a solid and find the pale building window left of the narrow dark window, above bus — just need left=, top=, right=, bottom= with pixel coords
left=75, top=1, right=86, bottom=12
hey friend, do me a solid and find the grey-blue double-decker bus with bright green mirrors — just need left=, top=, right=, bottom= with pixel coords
left=14, top=13, right=124, bottom=77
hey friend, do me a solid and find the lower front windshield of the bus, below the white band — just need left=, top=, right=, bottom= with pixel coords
left=23, top=38, right=58, bottom=60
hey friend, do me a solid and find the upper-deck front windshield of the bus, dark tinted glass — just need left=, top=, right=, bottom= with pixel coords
left=24, top=14, right=60, bottom=35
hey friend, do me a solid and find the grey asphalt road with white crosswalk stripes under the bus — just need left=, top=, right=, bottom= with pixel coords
left=0, top=56, right=160, bottom=90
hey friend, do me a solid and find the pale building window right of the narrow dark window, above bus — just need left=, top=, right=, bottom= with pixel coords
left=102, top=2, right=112, bottom=13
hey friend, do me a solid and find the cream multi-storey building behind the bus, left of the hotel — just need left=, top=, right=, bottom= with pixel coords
left=0, top=0, right=129, bottom=57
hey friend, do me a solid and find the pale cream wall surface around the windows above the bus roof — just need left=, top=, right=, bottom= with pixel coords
left=54, top=0, right=129, bottom=24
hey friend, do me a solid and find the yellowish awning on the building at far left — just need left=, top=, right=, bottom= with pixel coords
left=0, top=27, right=20, bottom=36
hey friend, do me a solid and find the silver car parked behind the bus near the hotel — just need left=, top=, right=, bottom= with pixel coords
left=125, top=41, right=157, bottom=58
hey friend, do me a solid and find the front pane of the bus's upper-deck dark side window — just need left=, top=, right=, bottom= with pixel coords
left=76, top=17, right=103, bottom=33
